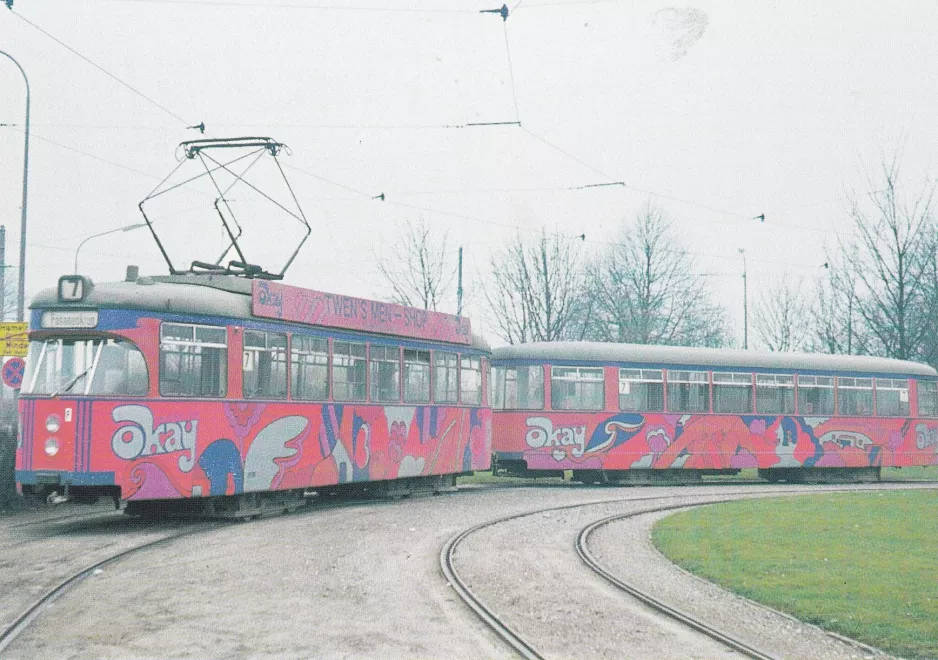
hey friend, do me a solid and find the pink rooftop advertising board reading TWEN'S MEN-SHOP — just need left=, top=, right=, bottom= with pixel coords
left=252, top=280, right=472, bottom=344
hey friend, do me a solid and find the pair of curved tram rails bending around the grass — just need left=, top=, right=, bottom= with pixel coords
left=439, top=485, right=924, bottom=660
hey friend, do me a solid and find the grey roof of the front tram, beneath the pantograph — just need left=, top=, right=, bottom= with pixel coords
left=29, top=273, right=490, bottom=350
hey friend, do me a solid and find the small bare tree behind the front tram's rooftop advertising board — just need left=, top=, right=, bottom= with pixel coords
left=378, top=221, right=457, bottom=310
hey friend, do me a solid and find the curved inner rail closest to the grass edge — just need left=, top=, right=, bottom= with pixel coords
left=574, top=506, right=776, bottom=660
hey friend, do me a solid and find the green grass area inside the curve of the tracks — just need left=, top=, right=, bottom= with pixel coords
left=652, top=490, right=938, bottom=659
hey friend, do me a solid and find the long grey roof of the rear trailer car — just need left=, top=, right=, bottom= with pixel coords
left=492, top=341, right=938, bottom=377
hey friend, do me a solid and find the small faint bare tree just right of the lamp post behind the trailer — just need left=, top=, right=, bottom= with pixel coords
left=752, top=279, right=813, bottom=352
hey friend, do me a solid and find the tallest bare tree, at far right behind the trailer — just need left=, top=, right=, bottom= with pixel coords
left=831, top=157, right=936, bottom=360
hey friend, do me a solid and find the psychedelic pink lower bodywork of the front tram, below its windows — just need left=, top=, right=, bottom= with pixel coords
left=18, top=399, right=491, bottom=500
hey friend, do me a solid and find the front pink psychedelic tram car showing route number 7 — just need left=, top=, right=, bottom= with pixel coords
left=16, top=269, right=491, bottom=516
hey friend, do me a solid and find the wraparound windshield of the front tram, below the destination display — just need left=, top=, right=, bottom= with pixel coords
left=22, top=338, right=149, bottom=396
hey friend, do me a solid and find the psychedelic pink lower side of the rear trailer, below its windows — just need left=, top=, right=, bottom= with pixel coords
left=492, top=410, right=938, bottom=471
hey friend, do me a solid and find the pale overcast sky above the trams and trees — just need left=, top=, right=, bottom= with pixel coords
left=0, top=0, right=938, bottom=344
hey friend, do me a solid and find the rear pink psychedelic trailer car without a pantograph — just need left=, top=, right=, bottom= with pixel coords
left=491, top=342, right=938, bottom=483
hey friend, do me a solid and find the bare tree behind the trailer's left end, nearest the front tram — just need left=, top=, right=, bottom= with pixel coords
left=485, top=233, right=582, bottom=344
